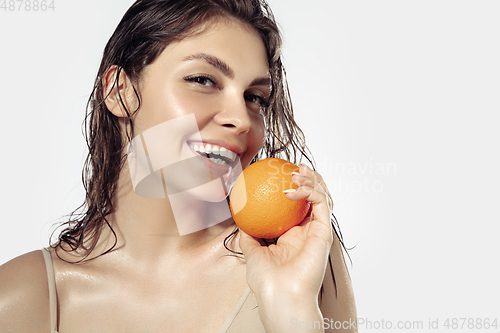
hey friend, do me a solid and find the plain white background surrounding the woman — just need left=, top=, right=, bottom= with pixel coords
left=0, top=0, right=500, bottom=332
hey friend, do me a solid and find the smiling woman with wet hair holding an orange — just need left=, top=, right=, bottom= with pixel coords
left=0, top=0, right=356, bottom=332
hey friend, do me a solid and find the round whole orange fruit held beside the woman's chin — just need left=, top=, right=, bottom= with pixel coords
left=229, top=158, right=310, bottom=238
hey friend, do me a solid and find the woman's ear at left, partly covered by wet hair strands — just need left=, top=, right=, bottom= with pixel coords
left=102, top=65, right=138, bottom=118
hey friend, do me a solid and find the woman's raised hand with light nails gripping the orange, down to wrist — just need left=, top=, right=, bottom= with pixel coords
left=231, top=160, right=333, bottom=299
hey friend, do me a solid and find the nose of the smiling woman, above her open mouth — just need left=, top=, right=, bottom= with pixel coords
left=214, top=92, right=252, bottom=134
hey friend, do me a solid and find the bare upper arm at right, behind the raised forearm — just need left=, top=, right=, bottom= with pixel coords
left=320, top=234, right=357, bottom=332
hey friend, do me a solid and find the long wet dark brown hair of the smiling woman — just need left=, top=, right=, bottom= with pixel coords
left=51, top=0, right=343, bottom=298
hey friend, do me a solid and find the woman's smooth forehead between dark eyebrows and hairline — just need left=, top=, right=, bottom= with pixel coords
left=145, top=19, right=268, bottom=76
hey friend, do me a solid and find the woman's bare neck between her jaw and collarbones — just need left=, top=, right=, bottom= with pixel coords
left=102, top=165, right=234, bottom=262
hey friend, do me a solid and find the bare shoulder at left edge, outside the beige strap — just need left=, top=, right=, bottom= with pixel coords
left=0, top=250, right=50, bottom=332
